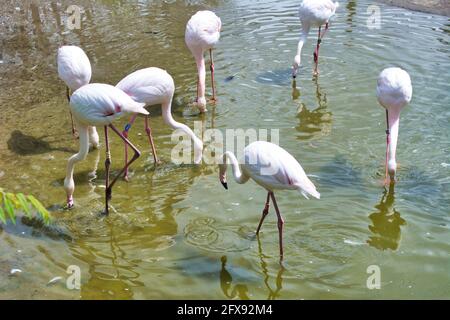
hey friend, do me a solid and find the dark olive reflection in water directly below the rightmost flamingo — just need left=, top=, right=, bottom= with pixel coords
left=367, top=184, right=406, bottom=250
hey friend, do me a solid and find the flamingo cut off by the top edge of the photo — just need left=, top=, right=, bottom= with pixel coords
left=292, top=0, right=339, bottom=78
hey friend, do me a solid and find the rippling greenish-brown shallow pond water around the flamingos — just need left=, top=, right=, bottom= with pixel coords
left=0, top=0, right=450, bottom=299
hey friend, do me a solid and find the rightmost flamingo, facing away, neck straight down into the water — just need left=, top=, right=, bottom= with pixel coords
left=377, top=68, right=412, bottom=185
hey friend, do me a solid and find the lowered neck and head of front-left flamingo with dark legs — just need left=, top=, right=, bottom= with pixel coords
left=64, top=124, right=89, bottom=208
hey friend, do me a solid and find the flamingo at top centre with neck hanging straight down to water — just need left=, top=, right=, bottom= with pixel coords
left=185, top=10, right=222, bottom=112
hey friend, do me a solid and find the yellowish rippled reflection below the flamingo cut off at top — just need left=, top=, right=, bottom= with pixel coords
left=292, top=79, right=333, bottom=140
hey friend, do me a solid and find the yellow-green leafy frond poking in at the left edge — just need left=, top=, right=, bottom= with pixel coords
left=0, top=188, right=50, bottom=224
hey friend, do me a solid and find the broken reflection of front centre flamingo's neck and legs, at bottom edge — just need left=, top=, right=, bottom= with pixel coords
left=220, top=238, right=285, bottom=300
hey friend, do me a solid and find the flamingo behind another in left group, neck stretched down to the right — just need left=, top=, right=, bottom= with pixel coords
left=116, top=68, right=203, bottom=180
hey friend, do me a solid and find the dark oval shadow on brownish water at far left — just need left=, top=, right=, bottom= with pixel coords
left=7, top=130, right=76, bottom=156
